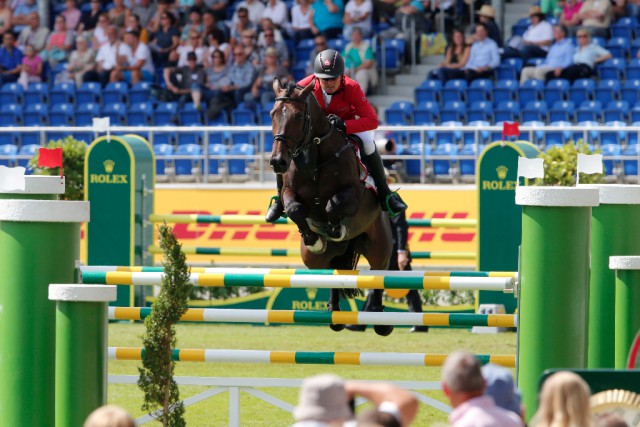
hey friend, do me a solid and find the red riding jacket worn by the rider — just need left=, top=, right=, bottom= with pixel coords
left=298, top=74, right=378, bottom=133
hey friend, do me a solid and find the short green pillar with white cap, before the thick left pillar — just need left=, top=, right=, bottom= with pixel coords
left=49, top=285, right=117, bottom=427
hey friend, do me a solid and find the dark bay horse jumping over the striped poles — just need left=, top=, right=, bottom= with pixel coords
left=270, top=79, right=393, bottom=335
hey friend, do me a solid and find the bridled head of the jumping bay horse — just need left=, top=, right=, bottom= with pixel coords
left=269, top=78, right=315, bottom=174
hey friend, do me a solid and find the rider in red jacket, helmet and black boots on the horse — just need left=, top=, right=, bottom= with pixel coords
left=266, top=49, right=407, bottom=222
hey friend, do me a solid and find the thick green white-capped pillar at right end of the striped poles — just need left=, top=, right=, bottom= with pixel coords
left=516, top=187, right=599, bottom=422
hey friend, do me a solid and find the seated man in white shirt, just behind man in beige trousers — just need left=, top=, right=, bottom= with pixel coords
left=503, top=6, right=553, bottom=63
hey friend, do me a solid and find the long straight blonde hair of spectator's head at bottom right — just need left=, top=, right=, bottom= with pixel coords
left=531, top=372, right=593, bottom=427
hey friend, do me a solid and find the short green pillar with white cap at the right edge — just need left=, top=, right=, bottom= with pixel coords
left=609, top=256, right=640, bottom=369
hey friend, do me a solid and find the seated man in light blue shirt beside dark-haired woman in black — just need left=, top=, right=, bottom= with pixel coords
left=441, top=23, right=500, bottom=82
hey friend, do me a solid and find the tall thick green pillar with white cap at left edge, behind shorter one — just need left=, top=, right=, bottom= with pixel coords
left=0, top=176, right=89, bottom=427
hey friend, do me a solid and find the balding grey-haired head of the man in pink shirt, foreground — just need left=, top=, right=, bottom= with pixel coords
left=442, top=351, right=485, bottom=407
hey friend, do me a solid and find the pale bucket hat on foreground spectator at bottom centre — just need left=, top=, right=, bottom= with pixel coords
left=293, top=374, right=351, bottom=422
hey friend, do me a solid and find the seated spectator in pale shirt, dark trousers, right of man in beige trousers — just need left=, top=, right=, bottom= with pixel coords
left=547, top=28, right=611, bottom=83
